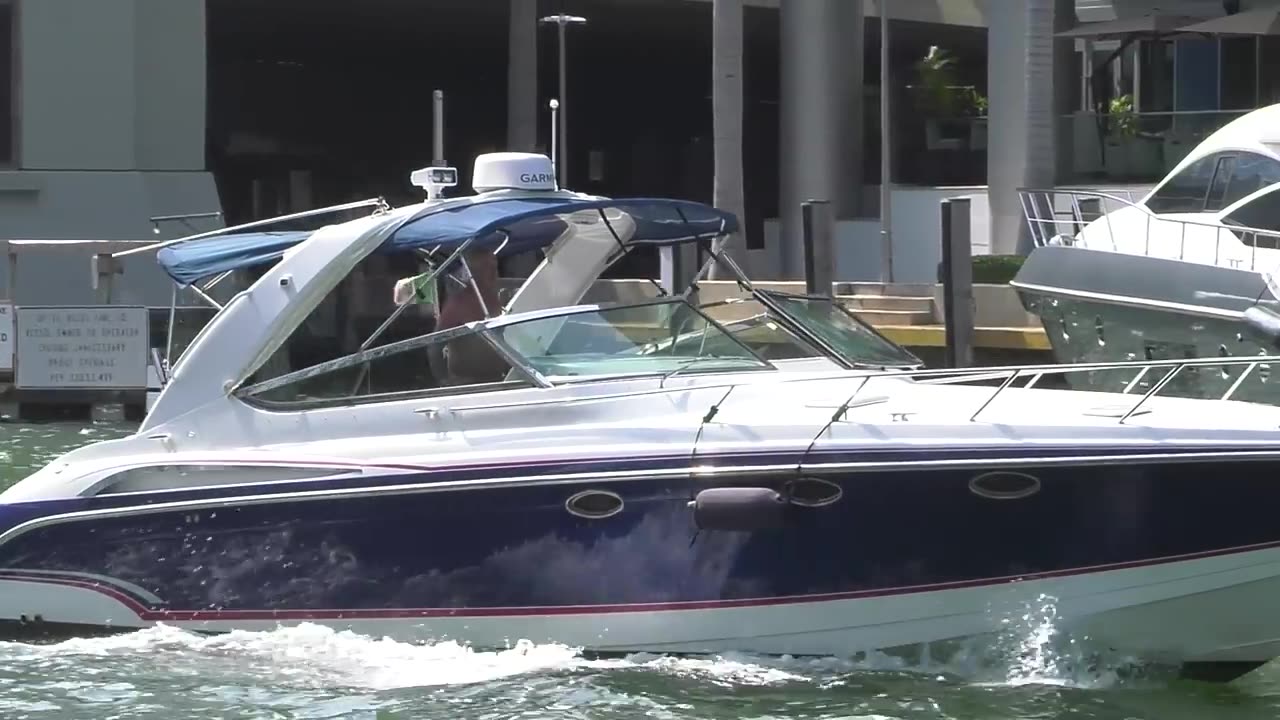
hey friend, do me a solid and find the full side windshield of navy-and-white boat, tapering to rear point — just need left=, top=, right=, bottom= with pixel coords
left=237, top=299, right=776, bottom=407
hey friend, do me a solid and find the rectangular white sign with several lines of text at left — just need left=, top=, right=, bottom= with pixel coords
left=14, top=305, right=151, bottom=389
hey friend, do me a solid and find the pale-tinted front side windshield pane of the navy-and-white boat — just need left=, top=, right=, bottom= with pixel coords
left=490, top=301, right=773, bottom=379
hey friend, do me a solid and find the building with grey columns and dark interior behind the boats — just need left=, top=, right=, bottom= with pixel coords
left=0, top=0, right=1271, bottom=292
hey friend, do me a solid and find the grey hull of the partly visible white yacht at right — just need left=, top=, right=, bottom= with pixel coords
left=1014, top=246, right=1280, bottom=405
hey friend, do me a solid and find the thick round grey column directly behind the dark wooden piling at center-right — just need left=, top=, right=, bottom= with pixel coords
left=780, top=0, right=864, bottom=277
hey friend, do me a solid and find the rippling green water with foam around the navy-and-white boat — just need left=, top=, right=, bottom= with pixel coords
left=0, top=425, right=1280, bottom=720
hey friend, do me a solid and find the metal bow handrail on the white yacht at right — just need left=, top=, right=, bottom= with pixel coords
left=1018, top=187, right=1280, bottom=272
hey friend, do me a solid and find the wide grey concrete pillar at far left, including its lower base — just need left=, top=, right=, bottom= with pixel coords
left=0, top=0, right=220, bottom=252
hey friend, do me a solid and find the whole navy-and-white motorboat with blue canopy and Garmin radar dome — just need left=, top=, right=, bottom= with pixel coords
left=0, top=151, right=1280, bottom=676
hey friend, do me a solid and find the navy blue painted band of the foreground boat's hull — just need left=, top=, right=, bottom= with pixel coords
left=0, top=443, right=1280, bottom=619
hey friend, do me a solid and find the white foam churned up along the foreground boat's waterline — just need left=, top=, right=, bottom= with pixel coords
left=0, top=596, right=1162, bottom=691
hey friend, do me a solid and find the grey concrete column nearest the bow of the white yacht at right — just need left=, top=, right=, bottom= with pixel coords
left=987, top=0, right=1059, bottom=254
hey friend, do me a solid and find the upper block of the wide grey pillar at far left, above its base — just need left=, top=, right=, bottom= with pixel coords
left=19, top=0, right=207, bottom=170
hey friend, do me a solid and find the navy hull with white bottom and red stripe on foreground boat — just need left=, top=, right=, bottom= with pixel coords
left=0, top=448, right=1280, bottom=664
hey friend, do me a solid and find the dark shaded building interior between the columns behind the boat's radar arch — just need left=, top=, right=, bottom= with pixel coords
left=207, top=0, right=986, bottom=274
